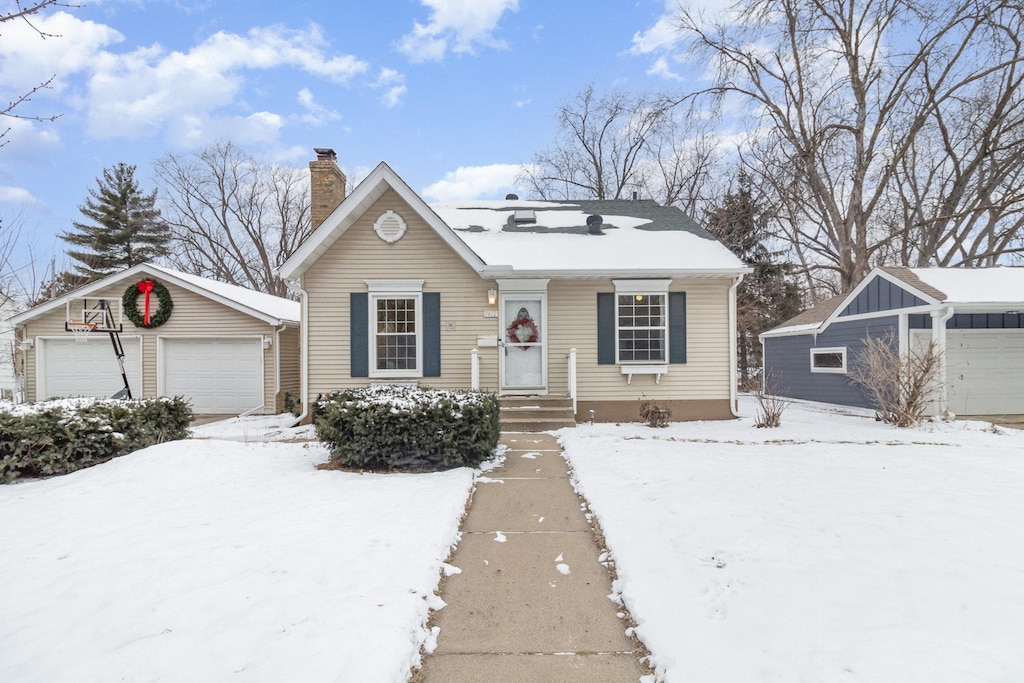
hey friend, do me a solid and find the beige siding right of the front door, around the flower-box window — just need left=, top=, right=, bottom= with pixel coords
left=548, top=279, right=732, bottom=400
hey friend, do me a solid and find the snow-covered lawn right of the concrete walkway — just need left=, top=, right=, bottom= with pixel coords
left=559, top=401, right=1024, bottom=683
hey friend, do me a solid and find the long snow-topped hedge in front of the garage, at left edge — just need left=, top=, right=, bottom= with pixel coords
left=0, top=397, right=193, bottom=482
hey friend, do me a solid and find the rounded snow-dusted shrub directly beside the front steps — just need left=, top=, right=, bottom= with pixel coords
left=313, top=386, right=501, bottom=471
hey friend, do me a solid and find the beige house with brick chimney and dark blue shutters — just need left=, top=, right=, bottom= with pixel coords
left=279, top=148, right=749, bottom=421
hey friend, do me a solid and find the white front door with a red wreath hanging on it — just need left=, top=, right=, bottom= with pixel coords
left=500, top=292, right=548, bottom=393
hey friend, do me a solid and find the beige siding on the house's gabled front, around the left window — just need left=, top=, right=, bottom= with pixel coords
left=303, top=189, right=498, bottom=399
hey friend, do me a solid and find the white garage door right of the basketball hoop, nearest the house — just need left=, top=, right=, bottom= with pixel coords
left=161, top=338, right=263, bottom=415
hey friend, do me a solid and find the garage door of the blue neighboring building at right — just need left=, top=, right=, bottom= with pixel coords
left=946, top=330, right=1024, bottom=415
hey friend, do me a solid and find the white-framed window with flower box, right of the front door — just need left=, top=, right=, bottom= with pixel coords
left=615, top=281, right=669, bottom=364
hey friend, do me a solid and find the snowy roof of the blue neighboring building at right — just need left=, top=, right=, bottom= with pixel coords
left=763, top=266, right=1024, bottom=337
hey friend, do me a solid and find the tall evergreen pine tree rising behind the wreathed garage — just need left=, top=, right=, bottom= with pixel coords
left=60, top=163, right=170, bottom=280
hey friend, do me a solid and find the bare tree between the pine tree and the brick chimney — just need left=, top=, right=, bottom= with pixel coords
left=156, top=142, right=310, bottom=296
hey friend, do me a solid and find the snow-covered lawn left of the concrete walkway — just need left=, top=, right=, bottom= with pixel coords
left=0, top=420, right=473, bottom=683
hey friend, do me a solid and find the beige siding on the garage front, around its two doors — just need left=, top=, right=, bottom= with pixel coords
left=26, top=276, right=284, bottom=413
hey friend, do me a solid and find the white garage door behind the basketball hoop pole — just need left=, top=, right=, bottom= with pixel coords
left=37, top=334, right=142, bottom=398
